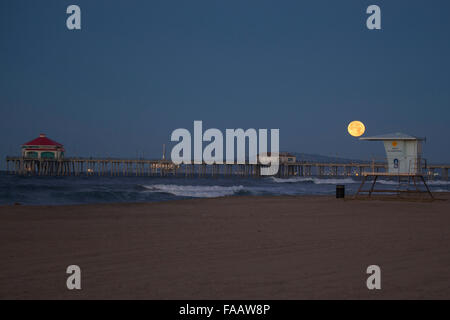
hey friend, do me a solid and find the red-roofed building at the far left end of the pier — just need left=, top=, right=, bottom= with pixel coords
left=22, top=133, right=64, bottom=159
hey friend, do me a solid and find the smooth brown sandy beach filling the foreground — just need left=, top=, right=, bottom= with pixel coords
left=0, top=194, right=450, bottom=299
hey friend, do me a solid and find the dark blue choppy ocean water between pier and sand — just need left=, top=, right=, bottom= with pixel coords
left=0, top=173, right=450, bottom=205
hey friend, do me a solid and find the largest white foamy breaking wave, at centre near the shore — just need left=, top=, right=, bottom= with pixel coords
left=143, top=184, right=244, bottom=198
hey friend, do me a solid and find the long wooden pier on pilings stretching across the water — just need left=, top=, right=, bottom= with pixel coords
left=6, top=157, right=450, bottom=180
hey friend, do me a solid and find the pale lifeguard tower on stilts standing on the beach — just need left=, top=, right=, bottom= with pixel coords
left=355, top=133, right=433, bottom=199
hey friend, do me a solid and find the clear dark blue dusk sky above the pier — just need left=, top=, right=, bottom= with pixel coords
left=0, top=0, right=450, bottom=167
